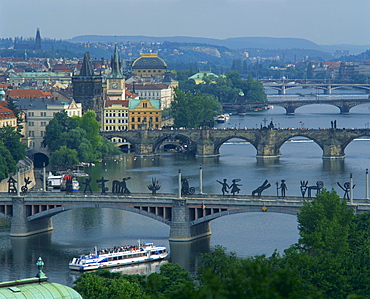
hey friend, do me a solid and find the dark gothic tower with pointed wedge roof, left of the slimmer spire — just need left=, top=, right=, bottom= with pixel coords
left=72, top=51, right=103, bottom=121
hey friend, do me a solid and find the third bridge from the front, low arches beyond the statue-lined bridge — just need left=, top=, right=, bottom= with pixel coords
left=222, top=97, right=370, bottom=115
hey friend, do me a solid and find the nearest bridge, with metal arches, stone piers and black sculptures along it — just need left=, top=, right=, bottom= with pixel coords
left=0, top=192, right=370, bottom=242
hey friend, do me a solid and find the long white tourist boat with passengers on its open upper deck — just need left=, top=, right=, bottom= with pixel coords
left=69, top=241, right=168, bottom=271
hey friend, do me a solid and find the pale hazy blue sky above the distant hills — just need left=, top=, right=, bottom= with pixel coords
left=0, top=0, right=370, bottom=45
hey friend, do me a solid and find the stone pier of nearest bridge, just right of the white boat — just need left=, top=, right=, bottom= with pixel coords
left=169, top=199, right=211, bottom=242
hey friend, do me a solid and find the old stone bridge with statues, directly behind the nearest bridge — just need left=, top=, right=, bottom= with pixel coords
left=100, top=129, right=370, bottom=159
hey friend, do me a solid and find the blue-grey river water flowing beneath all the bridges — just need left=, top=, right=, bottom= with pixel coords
left=0, top=90, right=370, bottom=286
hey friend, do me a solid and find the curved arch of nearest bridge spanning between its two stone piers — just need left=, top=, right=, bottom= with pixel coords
left=27, top=203, right=171, bottom=225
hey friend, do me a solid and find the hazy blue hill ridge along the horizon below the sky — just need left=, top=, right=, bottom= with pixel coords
left=68, top=35, right=370, bottom=55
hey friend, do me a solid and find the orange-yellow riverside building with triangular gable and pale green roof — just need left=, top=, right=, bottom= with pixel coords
left=129, top=99, right=162, bottom=130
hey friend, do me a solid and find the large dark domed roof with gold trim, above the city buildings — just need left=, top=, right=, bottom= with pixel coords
left=131, top=53, right=167, bottom=77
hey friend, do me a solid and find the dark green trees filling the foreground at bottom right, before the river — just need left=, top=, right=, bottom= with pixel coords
left=74, top=190, right=370, bottom=299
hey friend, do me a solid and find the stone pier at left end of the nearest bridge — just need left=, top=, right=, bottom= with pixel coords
left=10, top=197, right=53, bottom=237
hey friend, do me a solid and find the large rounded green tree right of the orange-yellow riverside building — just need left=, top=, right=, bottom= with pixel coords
left=171, top=88, right=221, bottom=128
